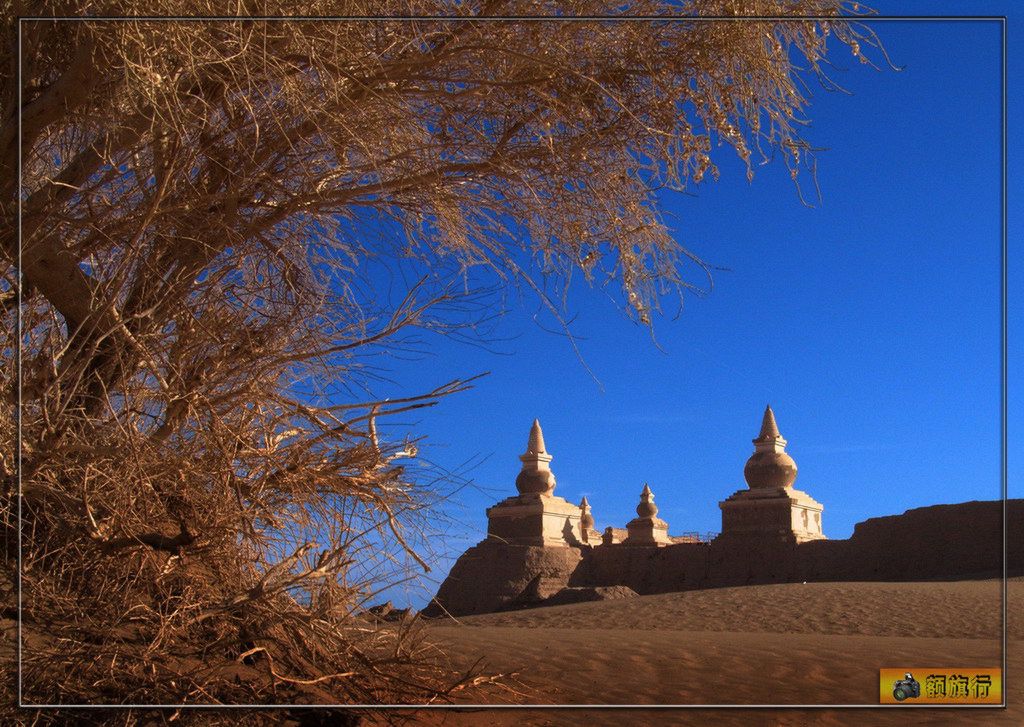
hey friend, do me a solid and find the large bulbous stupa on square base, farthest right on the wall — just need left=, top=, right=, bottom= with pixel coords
left=719, top=405, right=825, bottom=543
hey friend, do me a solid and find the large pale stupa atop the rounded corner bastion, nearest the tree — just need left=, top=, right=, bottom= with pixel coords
left=487, top=419, right=593, bottom=547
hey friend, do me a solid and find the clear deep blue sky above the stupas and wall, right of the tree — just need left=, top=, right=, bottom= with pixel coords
left=356, top=2, right=1011, bottom=605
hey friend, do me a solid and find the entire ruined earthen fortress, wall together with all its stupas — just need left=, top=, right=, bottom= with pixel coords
left=424, top=407, right=1024, bottom=616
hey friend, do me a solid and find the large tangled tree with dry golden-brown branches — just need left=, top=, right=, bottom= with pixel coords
left=0, top=0, right=877, bottom=716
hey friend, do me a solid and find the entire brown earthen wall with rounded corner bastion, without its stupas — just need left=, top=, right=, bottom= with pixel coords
left=424, top=500, right=1024, bottom=615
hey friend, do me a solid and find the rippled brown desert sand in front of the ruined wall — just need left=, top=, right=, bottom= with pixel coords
left=389, top=578, right=1024, bottom=725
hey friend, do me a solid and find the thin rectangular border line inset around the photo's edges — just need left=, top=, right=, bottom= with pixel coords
left=15, top=15, right=1008, bottom=710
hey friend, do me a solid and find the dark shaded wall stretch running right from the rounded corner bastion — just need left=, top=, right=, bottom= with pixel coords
left=581, top=500, right=1024, bottom=594
